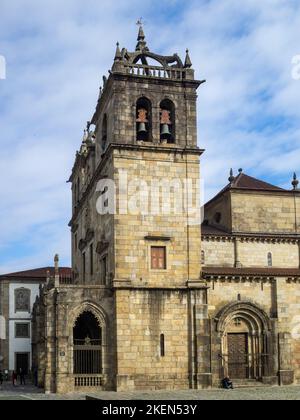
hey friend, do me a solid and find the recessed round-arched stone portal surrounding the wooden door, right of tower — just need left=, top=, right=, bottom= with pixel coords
left=218, top=302, right=272, bottom=380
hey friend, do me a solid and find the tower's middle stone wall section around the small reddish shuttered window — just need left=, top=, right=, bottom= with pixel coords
left=114, top=149, right=201, bottom=288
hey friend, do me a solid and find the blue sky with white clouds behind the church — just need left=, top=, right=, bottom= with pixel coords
left=0, top=0, right=300, bottom=273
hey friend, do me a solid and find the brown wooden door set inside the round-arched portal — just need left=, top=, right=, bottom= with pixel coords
left=227, top=334, right=248, bottom=379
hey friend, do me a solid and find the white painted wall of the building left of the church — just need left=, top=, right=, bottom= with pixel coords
left=9, top=282, right=39, bottom=370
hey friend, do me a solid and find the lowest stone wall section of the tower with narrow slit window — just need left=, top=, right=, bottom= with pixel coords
left=116, top=290, right=190, bottom=391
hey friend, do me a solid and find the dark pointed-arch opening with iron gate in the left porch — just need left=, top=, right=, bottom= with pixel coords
left=73, top=312, right=103, bottom=375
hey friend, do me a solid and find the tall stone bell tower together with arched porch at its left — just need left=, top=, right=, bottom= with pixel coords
left=34, top=26, right=211, bottom=392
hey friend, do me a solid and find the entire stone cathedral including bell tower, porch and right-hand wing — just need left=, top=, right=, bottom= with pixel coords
left=32, top=27, right=300, bottom=393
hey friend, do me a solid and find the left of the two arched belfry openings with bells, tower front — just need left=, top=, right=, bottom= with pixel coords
left=136, top=98, right=152, bottom=141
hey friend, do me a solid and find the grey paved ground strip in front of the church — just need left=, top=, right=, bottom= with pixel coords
left=0, top=384, right=300, bottom=401
